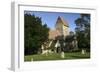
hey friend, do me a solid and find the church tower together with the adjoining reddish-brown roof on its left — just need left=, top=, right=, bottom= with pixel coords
left=49, top=16, right=70, bottom=40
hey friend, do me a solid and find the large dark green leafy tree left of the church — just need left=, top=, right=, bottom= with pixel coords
left=24, top=13, right=49, bottom=55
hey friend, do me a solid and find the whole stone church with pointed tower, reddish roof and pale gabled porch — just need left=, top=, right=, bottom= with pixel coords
left=41, top=16, right=77, bottom=54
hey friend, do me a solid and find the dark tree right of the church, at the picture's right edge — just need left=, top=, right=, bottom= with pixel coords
left=75, top=14, right=90, bottom=51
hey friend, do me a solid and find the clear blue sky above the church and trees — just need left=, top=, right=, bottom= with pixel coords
left=25, top=11, right=80, bottom=31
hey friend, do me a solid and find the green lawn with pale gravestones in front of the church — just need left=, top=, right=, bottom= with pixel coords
left=24, top=52, right=90, bottom=61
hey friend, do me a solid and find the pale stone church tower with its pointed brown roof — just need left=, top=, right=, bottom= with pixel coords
left=55, top=16, right=70, bottom=37
